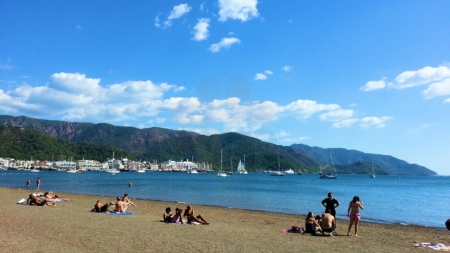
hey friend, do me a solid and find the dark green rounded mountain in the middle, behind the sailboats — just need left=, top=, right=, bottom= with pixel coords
left=139, top=133, right=320, bottom=172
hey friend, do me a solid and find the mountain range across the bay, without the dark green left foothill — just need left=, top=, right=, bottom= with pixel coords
left=0, top=115, right=436, bottom=175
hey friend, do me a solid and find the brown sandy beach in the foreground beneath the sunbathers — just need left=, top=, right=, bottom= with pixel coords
left=0, top=188, right=450, bottom=252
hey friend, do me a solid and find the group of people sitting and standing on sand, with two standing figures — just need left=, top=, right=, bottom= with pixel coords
left=305, top=192, right=364, bottom=236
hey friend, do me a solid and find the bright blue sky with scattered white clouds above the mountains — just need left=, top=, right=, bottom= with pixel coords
left=0, top=0, right=450, bottom=175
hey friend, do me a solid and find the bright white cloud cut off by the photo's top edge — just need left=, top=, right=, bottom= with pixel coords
left=219, top=0, right=259, bottom=22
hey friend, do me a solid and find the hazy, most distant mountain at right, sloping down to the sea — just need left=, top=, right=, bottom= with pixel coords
left=291, top=144, right=437, bottom=176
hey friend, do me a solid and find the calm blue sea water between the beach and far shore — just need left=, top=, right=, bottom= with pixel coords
left=0, top=171, right=450, bottom=228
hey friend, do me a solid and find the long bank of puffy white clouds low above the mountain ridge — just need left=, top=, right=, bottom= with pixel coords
left=0, top=72, right=389, bottom=132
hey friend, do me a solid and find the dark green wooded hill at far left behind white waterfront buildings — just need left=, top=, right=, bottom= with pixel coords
left=0, top=125, right=133, bottom=162
